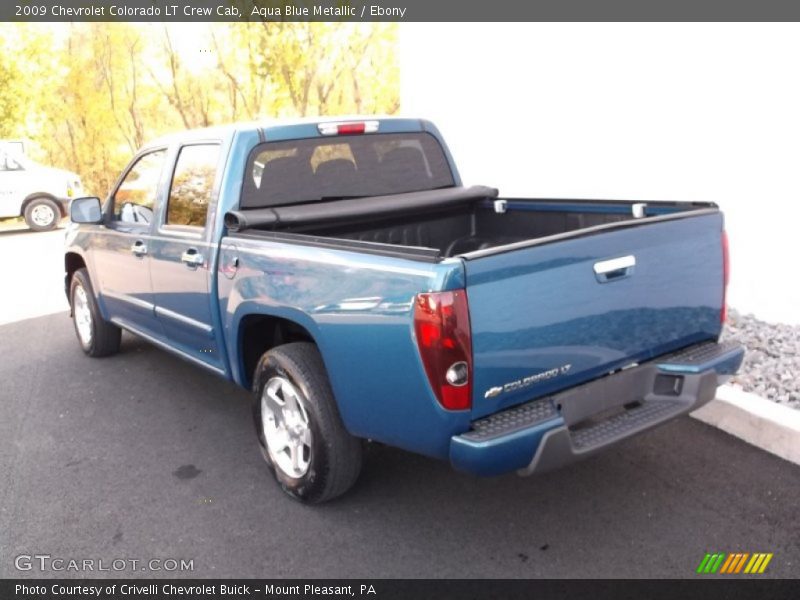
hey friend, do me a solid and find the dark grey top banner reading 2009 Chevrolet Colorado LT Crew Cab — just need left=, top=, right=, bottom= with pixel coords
left=0, top=0, right=800, bottom=22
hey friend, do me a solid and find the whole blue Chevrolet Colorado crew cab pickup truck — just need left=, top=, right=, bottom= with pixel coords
left=65, top=118, right=743, bottom=502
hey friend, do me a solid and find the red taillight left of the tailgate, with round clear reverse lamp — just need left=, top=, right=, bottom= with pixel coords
left=414, top=290, right=472, bottom=410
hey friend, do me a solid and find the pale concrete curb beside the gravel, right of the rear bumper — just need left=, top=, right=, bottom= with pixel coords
left=691, top=385, right=800, bottom=465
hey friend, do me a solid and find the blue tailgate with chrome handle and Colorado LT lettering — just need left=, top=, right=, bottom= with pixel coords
left=465, top=212, right=723, bottom=418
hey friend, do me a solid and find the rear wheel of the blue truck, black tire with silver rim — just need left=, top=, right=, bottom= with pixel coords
left=253, top=342, right=362, bottom=504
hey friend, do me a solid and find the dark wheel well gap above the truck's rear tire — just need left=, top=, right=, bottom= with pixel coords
left=239, top=315, right=315, bottom=385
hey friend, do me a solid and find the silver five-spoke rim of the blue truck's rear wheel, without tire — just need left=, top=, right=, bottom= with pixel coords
left=261, top=377, right=312, bottom=479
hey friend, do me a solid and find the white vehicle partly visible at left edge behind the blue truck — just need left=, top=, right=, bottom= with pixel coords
left=0, top=142, right=83, bottom=231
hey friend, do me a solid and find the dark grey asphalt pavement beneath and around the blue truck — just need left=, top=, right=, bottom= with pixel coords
left=0, top=227, right=800, bottom=578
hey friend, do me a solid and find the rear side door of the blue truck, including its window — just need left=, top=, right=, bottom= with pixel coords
left=151, top=142, right=222, bottom=369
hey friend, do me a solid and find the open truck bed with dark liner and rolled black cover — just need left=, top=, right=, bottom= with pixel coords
left=222, top=186, right=716, bottom=260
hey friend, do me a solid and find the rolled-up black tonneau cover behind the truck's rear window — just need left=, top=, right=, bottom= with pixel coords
left=225, top=185, right=497, bottom=231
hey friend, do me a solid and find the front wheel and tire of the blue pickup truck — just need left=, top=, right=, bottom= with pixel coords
left=69, top=269, right=122, bottom=358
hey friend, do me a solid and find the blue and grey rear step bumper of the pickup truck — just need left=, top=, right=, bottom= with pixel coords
left=450, top=342, right=744, bottom=476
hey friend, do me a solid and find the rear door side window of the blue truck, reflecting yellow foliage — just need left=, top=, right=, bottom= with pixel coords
left=166, top=144, right=220, bottom=227
